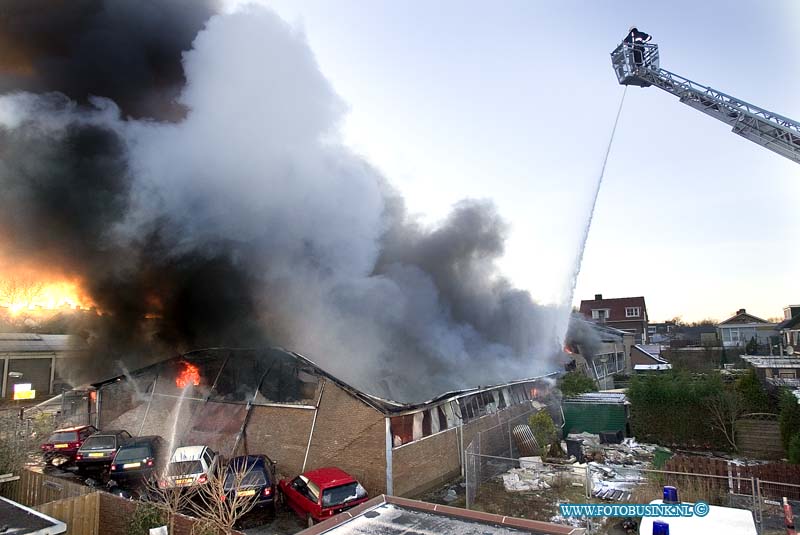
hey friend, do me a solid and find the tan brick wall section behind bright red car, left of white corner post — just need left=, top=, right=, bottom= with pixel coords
left=306, top=381, right=386, bottom=496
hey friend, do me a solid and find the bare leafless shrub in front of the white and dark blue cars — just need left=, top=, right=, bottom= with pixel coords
left=190, top=462, right=260, bottom=533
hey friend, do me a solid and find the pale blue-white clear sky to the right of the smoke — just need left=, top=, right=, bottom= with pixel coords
left=223, top=0, right=800, bottom=321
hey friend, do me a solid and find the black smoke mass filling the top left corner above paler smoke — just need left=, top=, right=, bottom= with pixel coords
left=0, top=0, right=216, bottom=119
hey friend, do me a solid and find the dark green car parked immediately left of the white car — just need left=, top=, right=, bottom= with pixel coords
left=109, top=436, right=168, bottom=486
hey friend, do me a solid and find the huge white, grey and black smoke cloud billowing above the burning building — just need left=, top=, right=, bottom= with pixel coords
left=0, top=4, right=566, bottom=401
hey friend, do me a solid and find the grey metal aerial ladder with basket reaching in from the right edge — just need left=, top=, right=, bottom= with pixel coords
left=611, top=42, right=800, bottom=163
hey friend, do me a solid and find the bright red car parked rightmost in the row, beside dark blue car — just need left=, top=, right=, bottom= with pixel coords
left=278, top=468, right=369, bottom=526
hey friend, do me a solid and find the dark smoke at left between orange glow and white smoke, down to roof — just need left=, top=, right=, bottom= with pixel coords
left=0, top=93, right=266, bottom=372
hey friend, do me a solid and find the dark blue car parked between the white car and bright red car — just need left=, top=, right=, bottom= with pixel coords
left=223, top=455, right=278, bottom=511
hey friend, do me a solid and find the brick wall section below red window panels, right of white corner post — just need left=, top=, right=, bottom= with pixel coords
left=392, top=428, right=460, bottom=496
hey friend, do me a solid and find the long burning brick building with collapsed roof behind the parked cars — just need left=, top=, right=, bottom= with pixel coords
left=93, top=349, right=553, bottom=496
